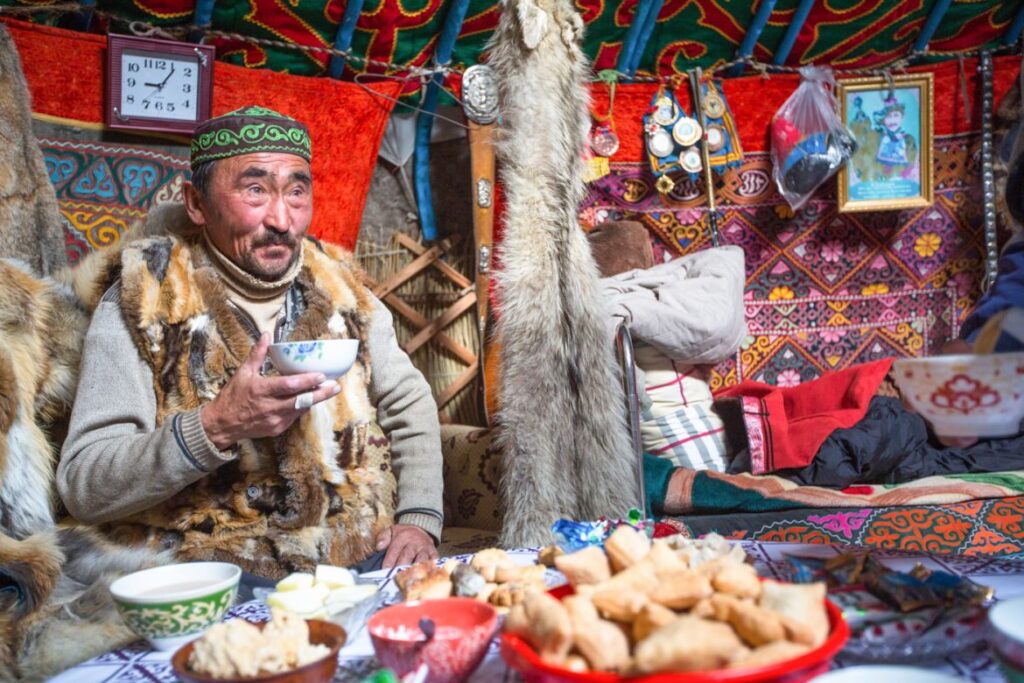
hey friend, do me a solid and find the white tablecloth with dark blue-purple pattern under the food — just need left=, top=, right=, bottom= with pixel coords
left=50, top=541, right=1024, bottom=683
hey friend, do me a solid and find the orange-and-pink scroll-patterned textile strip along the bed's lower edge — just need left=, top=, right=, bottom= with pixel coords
left=667, top=497, right=1024, bottom=559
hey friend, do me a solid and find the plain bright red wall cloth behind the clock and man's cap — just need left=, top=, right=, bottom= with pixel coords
left=4, top=19, right=398, bottom=248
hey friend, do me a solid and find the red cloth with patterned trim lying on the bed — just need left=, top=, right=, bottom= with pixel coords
left=716, top=358, right=893, bottom=474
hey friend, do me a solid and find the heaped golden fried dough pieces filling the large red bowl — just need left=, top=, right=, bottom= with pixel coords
left=505, top=525, right=829, bottom=674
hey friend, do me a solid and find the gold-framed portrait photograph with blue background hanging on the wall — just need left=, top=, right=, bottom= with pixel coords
left=836, top=74, right=934, bottom=212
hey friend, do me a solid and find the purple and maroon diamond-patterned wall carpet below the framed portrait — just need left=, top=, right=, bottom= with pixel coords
left=582, top=135, right=983, bottom=389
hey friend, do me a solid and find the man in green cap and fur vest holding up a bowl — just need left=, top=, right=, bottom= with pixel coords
left=57, top=106, right=442, bottom=579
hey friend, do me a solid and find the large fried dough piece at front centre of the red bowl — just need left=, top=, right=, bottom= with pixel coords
left=633, top=614, right=742, bottom=674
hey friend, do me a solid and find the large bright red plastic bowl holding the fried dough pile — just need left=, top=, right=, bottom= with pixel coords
left=502, top=586, right=850, bottom=683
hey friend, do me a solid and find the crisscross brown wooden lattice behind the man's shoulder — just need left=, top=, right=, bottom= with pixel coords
left=367, top=232, right=480, bottom=411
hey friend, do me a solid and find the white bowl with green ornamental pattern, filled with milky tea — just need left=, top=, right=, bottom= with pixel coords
left=111, top=562, right=242, bottom=651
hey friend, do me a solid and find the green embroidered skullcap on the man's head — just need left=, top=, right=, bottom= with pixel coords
left=191, top=105, right=312, bottom=171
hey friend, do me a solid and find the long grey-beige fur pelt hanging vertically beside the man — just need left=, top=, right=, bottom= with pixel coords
left=489, top=0, right=638, bottom=547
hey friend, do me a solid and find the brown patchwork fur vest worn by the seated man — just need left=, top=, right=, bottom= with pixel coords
left=105, top=237, right=396, bottom=578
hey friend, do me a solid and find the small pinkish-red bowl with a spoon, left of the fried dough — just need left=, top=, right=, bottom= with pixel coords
left=367, top=598, right=498, bottom=683
